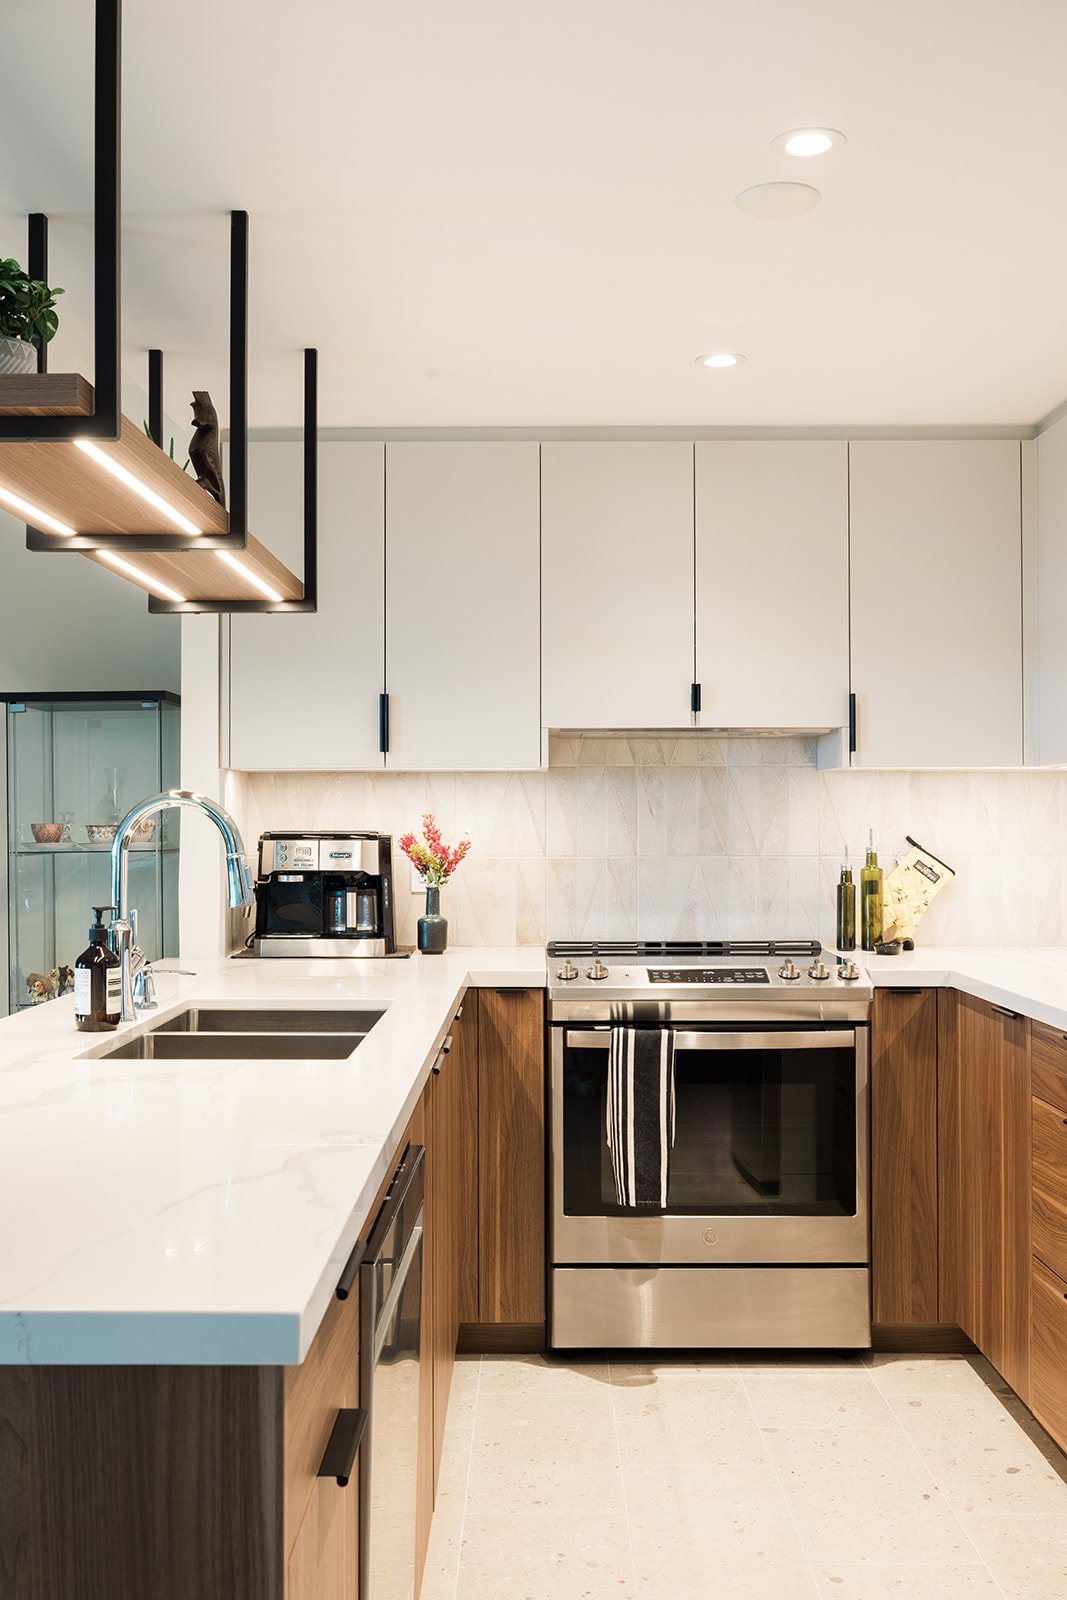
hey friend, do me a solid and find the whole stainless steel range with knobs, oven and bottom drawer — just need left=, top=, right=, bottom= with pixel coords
left=549, top=941, right=870, bottom=1349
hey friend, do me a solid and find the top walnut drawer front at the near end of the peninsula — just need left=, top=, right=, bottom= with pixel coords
left=285, top=1278, right=360, bottom=1557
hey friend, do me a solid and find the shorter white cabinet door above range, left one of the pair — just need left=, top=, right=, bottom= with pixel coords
left=541, top=442, right=694, bottom=728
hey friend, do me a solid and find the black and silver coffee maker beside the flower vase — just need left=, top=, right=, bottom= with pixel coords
left=253, top=830, right=397, bottom=958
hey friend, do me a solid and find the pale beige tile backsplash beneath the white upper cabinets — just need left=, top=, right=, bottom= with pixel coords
left=227, top=734, right=1067, bottom=944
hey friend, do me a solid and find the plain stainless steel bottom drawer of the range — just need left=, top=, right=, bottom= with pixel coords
left=549, top=1266, right=870, bottom=1350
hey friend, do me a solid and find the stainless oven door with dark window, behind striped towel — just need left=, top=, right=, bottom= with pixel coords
left=550, top=1024, right=869, bottom=1266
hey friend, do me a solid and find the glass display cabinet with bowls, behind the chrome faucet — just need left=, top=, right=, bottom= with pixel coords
left=0, top=693, right=181, bottom=1011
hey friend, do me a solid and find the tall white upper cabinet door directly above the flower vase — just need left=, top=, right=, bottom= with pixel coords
left=386, top=442, right=541, bottom=771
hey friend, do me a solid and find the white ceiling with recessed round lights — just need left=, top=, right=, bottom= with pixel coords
left=0, top=0, right=1067, bottom=427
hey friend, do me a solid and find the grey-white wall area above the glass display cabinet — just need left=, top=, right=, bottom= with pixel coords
left=0, top=512, right=181, bottom=694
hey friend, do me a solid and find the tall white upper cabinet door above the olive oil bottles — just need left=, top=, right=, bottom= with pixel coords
left=849, top=440, right=1022, bottom=766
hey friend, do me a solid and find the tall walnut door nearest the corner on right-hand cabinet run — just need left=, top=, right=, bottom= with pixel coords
left=957, top=995, right=1032, bottom=1400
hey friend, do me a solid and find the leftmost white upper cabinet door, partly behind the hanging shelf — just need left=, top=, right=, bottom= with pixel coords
left=229, top=443, right=386, bottom=771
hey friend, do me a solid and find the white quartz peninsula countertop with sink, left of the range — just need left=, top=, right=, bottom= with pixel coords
left=0, top=949, right=545, bottom=1365
